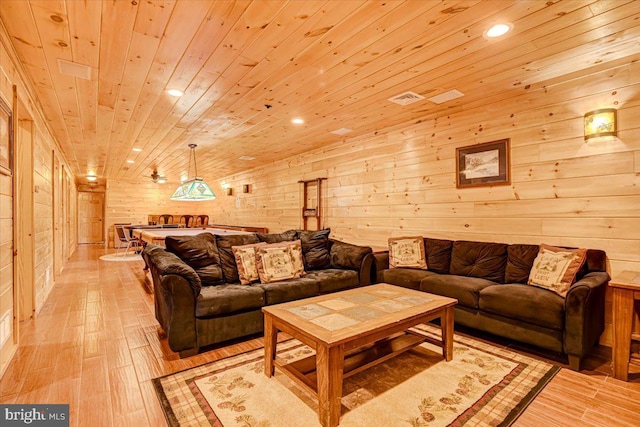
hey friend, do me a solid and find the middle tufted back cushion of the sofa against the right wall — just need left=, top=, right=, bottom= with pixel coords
left=449, top=240, right=507, bottom=283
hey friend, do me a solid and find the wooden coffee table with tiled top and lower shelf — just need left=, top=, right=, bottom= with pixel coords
left=262, top=283, right=458, bottom=427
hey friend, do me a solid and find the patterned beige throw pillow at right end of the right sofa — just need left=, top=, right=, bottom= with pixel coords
left=527, top=244, right=587, bottom=298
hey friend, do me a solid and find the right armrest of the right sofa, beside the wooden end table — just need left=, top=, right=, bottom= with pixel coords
left=564, top=271, right=609, bottom=359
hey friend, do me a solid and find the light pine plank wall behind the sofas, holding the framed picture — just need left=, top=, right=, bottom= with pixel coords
left=214, top=63, right=640, bottom=344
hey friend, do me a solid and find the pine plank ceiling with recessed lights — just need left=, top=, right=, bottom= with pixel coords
left=0, top=0, right=640, bottom=183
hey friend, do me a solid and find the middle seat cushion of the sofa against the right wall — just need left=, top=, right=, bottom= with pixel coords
left=420, top=274, right=496, bottom=308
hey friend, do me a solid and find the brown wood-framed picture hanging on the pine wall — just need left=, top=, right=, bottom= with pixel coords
left=456, top=138, right=511, bottom=188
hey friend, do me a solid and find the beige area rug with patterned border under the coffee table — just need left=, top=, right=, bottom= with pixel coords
left=153, top=325, right=560, bottom=427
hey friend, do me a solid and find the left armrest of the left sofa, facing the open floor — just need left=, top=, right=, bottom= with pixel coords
left=143, top=245, right=202, bottom=352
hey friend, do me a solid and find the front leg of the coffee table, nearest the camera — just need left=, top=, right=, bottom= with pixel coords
left=316, top=345, right=344, bottom=427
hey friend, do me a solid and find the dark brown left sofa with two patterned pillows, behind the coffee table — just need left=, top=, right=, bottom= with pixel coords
left=142, top=230, right=373, bottom=357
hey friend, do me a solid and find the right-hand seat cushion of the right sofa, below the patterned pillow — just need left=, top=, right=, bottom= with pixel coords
left=480, top=284, right=564, bottom=330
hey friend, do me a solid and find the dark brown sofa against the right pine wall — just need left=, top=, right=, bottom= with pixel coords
left=374, top=238, right=609, bottom=371
